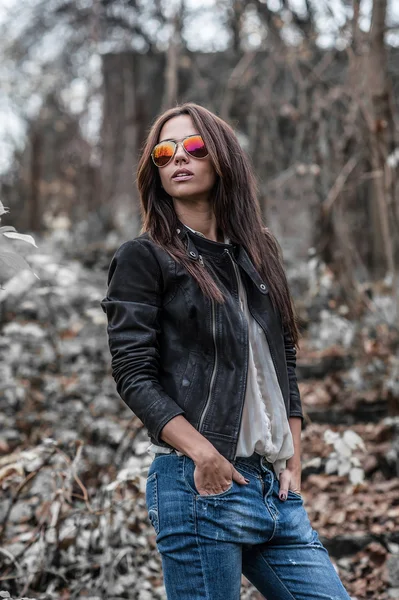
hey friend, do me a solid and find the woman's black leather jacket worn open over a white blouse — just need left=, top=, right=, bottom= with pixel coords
left=101, top=223, right=303, bottom=460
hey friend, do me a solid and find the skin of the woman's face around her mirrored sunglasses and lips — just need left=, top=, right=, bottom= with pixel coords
left=158, top=115, right=216, bottom=201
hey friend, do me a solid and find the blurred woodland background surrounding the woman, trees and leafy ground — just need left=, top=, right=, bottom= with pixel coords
left=0, top=0, right=399, bottom=600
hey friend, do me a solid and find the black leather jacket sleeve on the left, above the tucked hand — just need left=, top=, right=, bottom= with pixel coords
left=101, top=240, right=184, bottom=443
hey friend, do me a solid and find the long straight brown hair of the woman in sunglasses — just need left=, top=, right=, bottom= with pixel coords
left=137, top=102, right=299, bottom=346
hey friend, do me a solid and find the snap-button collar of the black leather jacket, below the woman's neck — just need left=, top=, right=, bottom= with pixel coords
left=177, top=219, right=269, bottom=294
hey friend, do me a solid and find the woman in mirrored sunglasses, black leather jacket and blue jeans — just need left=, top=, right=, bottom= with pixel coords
left=102, top=103, right=349, bottom=600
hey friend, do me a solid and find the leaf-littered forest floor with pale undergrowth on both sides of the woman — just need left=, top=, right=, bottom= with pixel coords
left=0, top=236, right=399, bottom=600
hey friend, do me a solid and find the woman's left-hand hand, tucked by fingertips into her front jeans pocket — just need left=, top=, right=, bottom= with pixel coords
left=194, top=451, right=249, bottom=496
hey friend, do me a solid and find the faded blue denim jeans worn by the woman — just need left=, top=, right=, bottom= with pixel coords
left=146, top=453, right=350, bottom=600
